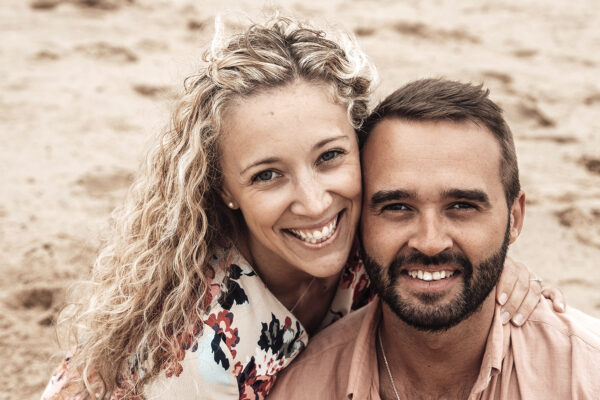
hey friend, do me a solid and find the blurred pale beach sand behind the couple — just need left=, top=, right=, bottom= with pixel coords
left=0, top=0, right=600, bottom=399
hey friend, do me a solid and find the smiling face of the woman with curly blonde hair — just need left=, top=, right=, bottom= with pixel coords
left=221, top=80, right=361, bottom=277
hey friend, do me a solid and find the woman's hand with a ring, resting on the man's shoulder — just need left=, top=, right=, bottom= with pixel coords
left=496, top=257, right=565, bottom=326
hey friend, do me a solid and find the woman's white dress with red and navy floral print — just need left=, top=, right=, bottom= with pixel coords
left=42, top=242, right=373, bottom=400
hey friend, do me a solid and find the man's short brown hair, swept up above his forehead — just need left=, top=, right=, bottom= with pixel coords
left=359, top=79, right=521, bottom=207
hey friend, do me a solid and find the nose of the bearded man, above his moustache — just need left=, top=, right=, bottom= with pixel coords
left=408, top=210, right=452, bottom=257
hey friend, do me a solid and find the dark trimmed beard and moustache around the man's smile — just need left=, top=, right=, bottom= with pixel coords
left=363, top=224, right=510, bottom=332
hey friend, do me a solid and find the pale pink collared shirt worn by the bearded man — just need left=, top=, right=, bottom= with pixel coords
left=269, top=299, right=600, bottom=400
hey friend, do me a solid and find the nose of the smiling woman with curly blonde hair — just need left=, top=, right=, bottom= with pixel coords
left=291, top=173, right=333, bottom=217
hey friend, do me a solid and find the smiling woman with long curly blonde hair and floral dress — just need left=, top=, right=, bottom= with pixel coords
left=43, top=18, right=564, bottom=399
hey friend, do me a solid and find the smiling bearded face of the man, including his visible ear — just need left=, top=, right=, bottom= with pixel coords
left=361, top=118, right=524, bottom=331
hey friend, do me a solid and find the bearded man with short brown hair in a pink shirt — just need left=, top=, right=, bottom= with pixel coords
left=272, top=79, right=600, bottom=400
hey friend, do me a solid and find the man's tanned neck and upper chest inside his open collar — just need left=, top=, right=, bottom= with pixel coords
left=378, top=291, right=495, bottom=399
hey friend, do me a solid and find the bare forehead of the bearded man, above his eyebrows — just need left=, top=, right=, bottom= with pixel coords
left=362, top=118, right=501, bottom=190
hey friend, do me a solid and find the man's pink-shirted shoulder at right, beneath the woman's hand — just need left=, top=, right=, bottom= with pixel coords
left=502, top=299, right=600, bottom=399
